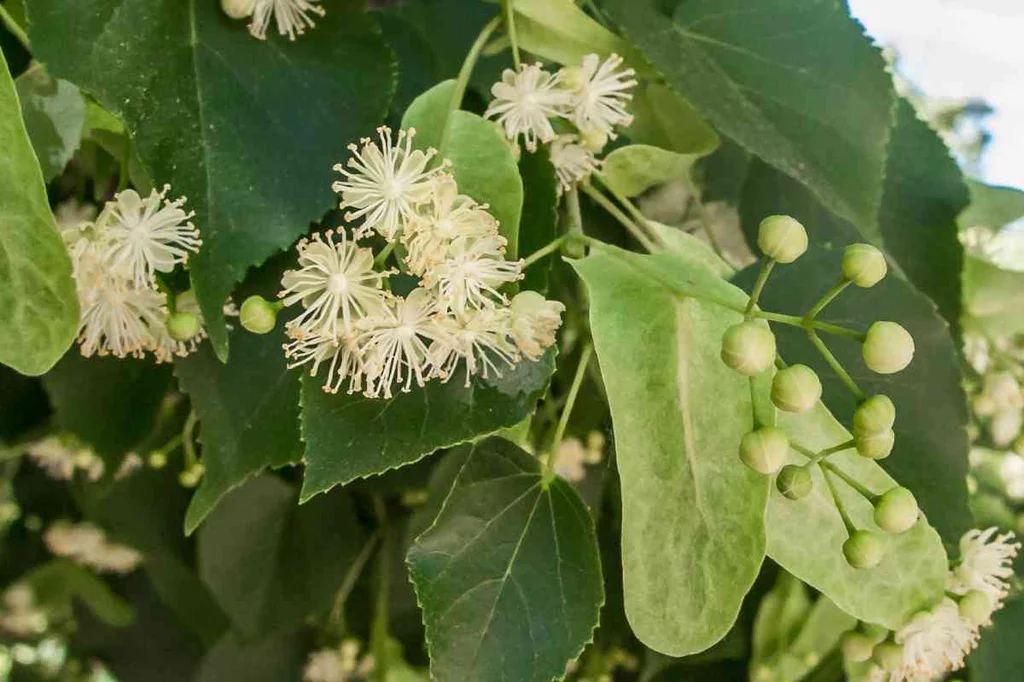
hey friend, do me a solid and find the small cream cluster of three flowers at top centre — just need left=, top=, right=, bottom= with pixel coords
left=484, top=54, right=637, bottom=190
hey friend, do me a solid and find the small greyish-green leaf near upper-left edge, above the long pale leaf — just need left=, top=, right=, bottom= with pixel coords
left=15, top=63, right=85, bottom=182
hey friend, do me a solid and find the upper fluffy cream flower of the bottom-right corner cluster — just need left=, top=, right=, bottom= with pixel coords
left=949, top=526, right=1021, bottom=608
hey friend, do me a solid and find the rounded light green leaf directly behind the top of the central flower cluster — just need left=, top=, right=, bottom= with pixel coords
left=401, top=81, right=522, bottom=260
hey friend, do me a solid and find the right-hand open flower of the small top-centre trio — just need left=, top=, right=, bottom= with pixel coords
left=562, top=54, right=637, bottom=139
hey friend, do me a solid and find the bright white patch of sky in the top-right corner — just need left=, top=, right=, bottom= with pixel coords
left=849, top=0, right=1024, bottom=187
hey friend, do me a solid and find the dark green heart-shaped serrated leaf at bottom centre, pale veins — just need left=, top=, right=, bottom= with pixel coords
left=408, top=438, right=604, bottom=682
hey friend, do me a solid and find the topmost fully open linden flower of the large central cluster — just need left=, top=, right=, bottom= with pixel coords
left=332, top=126, right=440, bottom=242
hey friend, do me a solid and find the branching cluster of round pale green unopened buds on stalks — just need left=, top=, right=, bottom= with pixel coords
left=721, top=215, right=920, bottom=568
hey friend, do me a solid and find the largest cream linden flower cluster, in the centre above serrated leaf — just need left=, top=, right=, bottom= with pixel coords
left=280, top=127, right=564, bottom=398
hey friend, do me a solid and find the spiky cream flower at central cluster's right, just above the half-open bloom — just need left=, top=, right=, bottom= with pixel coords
left=423, top=237, right=522, bottom=314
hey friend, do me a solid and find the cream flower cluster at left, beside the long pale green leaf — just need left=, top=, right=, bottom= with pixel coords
left=60, top=186, right=204, bottom=363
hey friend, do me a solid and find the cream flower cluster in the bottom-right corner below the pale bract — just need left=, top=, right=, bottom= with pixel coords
left=867, top=528, right=1021, bottom=682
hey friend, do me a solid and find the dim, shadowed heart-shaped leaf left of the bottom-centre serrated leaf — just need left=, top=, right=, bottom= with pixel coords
left=199, top=475, right=362, bottom=637
